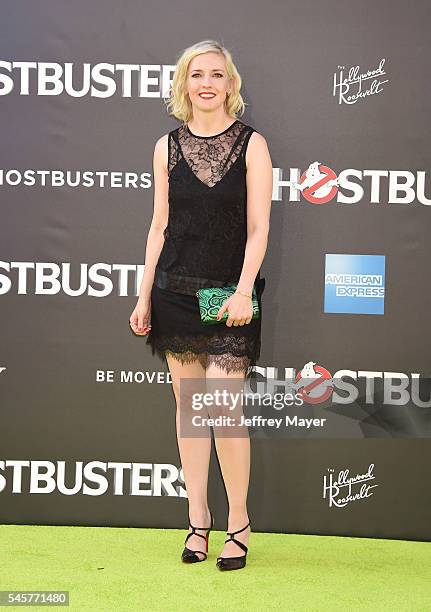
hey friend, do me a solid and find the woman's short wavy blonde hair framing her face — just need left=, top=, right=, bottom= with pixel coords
left=164, top=40, right=247, bottom=123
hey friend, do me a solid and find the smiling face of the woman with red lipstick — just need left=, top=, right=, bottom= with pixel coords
left=187, top=51, right=232, bottom=111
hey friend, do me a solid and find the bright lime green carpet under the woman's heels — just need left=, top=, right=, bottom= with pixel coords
left=0, top=525, right=431, bottom=612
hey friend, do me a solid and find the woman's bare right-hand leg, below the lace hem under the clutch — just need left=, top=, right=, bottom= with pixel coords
left=206, top=355, right=250, bottom=557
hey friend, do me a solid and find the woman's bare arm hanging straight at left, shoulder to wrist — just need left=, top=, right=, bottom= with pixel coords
left=138, top=134, right=169, bottom=303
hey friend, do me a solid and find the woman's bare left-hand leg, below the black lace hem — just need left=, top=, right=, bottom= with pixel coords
left=166, top=352, right=211, bottom=558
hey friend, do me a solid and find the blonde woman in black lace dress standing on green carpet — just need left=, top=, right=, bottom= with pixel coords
left=130, top=40, right=272, bottom=570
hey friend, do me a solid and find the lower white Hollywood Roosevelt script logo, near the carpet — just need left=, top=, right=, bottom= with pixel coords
left=323, top=463, right=378, bottom=508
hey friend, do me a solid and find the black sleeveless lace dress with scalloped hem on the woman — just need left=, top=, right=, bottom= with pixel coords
left=147, top=119, right=265, bottom=376
